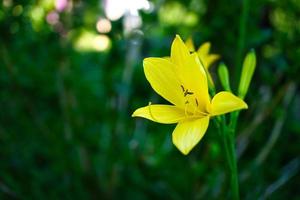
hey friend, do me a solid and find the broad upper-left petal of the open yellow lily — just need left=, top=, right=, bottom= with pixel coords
left=144, top=58, right=184, bottom=107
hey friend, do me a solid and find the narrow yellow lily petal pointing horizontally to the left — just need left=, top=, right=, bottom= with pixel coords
left=132, top=105, right=185, bottom=124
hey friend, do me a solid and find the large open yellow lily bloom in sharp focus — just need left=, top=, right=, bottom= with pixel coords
left=132, top=36, right=247, bottom=155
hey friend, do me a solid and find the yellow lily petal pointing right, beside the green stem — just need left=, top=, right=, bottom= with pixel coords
left=211, top=92, right=248, bottom=116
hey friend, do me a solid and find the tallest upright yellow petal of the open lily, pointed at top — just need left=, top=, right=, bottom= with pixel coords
left=171, top=35, right=209, bottom=112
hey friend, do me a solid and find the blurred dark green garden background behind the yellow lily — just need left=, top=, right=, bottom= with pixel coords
left=0, top=0, right=300, bottom=200
